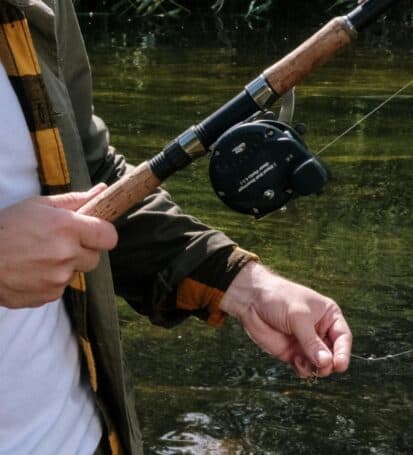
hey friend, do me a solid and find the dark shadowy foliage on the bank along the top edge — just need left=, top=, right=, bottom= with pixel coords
left=74, top=0, right=413, bottom=38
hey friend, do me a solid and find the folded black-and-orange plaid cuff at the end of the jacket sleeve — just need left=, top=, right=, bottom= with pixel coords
left=176, top=246, right=259, bottom=327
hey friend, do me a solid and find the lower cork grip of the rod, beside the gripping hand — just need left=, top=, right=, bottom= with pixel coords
left=78, top=161, right=161, bottom=221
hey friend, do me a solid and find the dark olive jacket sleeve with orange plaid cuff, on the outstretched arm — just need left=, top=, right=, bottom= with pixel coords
left=59, top=2, right=255, bottom=326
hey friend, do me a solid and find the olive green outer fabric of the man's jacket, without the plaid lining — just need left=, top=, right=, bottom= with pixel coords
left=0, top=0, right=251, bottom=455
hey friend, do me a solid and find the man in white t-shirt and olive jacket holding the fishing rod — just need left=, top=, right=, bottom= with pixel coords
left=0, top=0, right=351, bottom=455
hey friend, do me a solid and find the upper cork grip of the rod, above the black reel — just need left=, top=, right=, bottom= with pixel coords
left=263, top=17, right=356, bottom=96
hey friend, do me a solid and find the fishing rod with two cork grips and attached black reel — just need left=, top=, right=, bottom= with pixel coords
left=79, top=0, right=398, bottom=221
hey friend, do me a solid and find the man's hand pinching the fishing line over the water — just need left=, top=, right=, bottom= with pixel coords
left=220, top=262, right=352, bottom=378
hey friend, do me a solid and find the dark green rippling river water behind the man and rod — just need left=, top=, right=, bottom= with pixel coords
left=82, top=12, right=413, bottom=455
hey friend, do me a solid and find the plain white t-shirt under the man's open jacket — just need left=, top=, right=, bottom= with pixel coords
left=0, top=62, right=102, bottom=455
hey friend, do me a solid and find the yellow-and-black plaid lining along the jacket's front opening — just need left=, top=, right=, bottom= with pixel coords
left=0, top=0, right=120, bottom=454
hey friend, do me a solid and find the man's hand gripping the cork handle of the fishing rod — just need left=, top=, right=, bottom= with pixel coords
left=0, top=184, right=117, bottom=308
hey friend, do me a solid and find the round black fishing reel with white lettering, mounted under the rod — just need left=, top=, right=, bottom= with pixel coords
left=209, top=118, right=329, bottom=218
